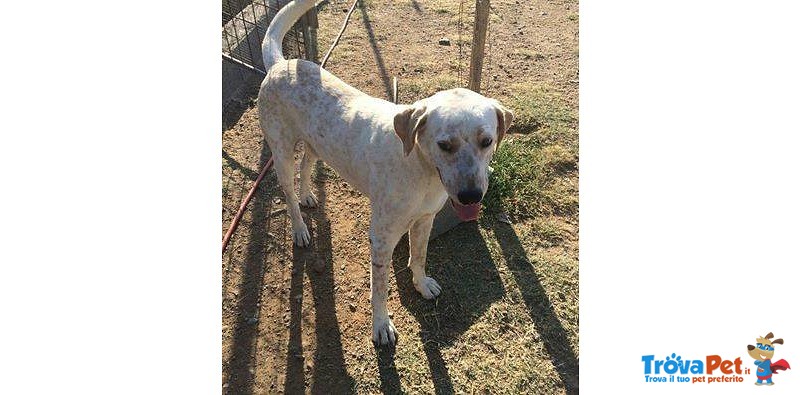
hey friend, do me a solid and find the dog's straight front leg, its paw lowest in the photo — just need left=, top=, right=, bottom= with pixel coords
left=369, top=223, right=399, bottom=345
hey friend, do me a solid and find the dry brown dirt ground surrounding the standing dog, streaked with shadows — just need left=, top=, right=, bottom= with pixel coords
left=221, top=0, right=579, bottom=394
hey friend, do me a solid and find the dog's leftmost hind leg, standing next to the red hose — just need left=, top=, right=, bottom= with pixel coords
left=272, top=144, right=311, bottom=247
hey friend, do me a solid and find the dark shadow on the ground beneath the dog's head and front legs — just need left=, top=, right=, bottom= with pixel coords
left=377, top=222, right=505, bottom=394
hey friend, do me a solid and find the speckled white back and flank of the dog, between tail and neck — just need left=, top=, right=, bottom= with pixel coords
left=258, top=59, right=403, bottom=195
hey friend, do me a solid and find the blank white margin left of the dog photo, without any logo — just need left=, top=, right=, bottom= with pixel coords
left=0, top=1, right=222, bottom=394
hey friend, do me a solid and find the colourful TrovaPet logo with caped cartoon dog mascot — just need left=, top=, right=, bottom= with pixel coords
left=642, top=332, right=790, bottom=385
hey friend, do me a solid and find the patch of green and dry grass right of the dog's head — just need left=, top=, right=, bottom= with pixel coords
left=486, top=85, right=578, bottom=218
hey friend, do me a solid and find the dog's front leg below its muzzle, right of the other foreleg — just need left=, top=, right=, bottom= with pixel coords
left=408, top=214, right=442, bottom=299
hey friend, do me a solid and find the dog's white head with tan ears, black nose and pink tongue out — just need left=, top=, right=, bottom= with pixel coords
left=394, top=88, right=514, bottom=220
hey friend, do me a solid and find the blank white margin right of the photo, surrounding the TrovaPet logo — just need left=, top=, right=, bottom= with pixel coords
left=580, top=0, right=800, bottom=394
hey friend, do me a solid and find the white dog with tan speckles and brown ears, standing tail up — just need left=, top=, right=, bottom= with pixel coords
left=258, top=0, right=513, bottom=344
